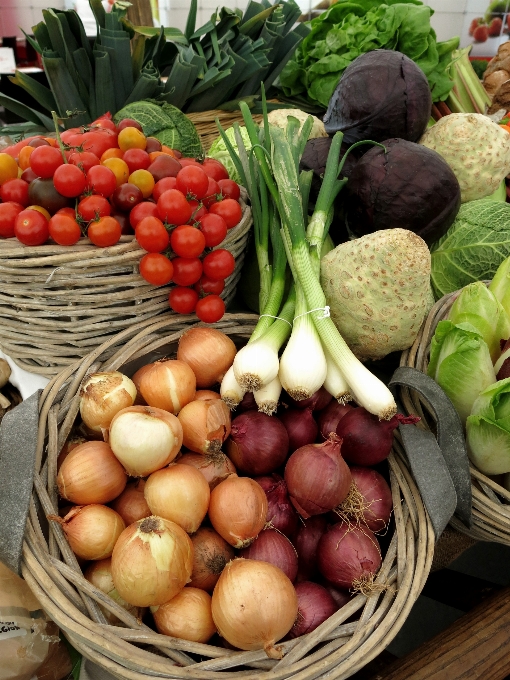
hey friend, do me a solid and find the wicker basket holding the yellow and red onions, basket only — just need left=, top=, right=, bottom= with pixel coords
left=22, top=314, right=434, bottom=680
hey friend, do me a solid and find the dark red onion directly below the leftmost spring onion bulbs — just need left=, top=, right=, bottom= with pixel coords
left=225, top=411, right=289, bottom=476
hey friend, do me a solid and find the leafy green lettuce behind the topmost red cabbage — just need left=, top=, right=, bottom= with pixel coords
left=280, top=0, right=459, bottom=109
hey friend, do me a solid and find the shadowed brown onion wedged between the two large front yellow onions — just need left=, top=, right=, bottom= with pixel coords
left=189, top=527, right=235, bottom=593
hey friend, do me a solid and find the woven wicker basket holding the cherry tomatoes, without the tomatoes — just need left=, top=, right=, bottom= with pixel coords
left=0, top=189, right=252, bottom=377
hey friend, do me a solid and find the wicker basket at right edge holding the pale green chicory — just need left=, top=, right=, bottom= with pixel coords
left=400, top=291, right=510, bottom=545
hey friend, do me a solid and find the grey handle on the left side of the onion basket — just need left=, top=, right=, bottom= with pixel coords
left=0, top=390, right=42, bottom=576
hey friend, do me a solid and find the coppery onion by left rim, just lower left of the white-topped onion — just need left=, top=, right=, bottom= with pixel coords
left=57, top=441, right=127, bottom=505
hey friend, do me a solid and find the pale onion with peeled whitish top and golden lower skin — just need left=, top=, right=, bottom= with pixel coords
left=108, top=406, right=182, bottom=477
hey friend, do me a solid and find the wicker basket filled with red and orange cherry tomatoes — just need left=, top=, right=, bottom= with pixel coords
left=0, top=115, right=252, bottom=376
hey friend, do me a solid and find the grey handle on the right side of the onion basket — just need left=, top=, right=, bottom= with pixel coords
left=389, top=366, right=472, bottom=528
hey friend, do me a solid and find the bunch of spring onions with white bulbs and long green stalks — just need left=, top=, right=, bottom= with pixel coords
left=216, top=90, right=396, bottom=419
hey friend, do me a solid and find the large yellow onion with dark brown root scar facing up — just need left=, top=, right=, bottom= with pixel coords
left=112, top=516, right=193, bottom=607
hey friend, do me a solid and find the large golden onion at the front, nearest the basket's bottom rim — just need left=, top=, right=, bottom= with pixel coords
left=212, top=558, right=298, bottom=659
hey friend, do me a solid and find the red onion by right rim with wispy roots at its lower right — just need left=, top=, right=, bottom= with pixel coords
left=317, top=522, right=381, bottom=594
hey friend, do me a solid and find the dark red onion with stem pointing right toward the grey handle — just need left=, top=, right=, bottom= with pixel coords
left=336, top=406, right=420, bottom=465
